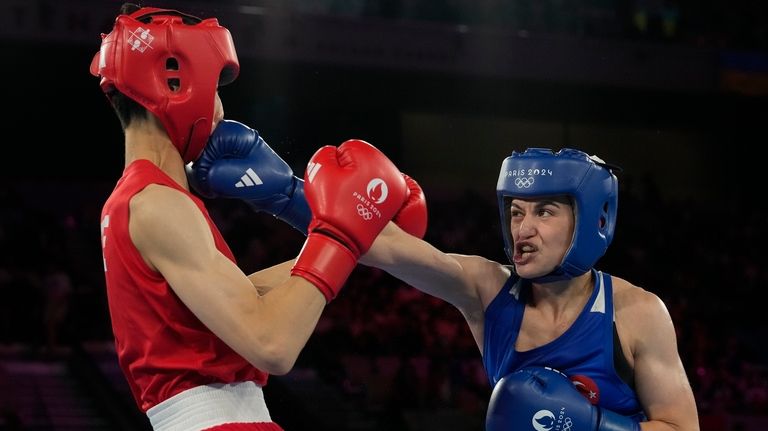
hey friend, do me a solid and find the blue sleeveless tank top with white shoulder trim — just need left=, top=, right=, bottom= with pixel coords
left=483, top=270, right=643, bottom=420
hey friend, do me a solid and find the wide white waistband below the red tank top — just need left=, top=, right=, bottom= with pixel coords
left=147, top=382, right=272, bottom=431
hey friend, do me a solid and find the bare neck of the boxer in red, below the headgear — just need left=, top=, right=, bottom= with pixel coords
left=125, top=122, right=189, bottom=189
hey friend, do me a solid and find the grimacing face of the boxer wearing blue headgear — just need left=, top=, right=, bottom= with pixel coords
left=509, top=196, right=575, bottom=278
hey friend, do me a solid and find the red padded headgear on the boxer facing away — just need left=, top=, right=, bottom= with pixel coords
left=91, top=7, right=240, bottom=163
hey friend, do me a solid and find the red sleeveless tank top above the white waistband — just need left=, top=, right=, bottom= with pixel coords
left=101, top=160, right=267, bottom=412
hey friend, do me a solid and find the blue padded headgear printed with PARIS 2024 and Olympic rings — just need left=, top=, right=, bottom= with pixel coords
left=496, top=148, right=619, bottom=283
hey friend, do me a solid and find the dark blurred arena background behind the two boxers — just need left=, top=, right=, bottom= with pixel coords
left=0, top=0, right=768, bottom=431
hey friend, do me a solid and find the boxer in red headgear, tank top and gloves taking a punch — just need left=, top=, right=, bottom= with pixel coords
left=91, top=4, right=407, bottom=431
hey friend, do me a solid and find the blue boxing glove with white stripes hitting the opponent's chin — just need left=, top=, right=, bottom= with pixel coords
left=187, top=120, right=312, bottom=235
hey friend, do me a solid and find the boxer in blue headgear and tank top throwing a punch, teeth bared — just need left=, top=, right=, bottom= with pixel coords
left=361, top=148, right=699, bottom=431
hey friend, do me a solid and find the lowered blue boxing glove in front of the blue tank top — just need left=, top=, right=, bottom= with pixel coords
left=485, top=367, right=640, bottom=431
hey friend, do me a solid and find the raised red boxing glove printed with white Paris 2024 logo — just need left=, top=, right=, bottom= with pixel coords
left=291, top=139, right=408, bottom=301
